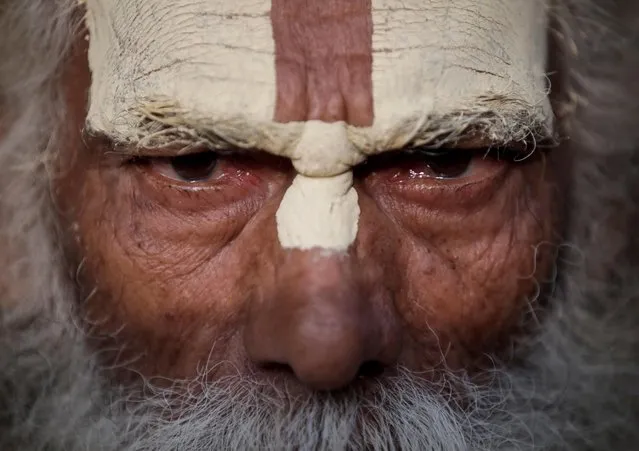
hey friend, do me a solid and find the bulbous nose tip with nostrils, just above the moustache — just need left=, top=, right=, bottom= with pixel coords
left=245, top=298, right=397, bottom=391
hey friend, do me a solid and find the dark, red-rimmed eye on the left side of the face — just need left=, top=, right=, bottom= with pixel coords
left=149, top=152, right=218, bottom=183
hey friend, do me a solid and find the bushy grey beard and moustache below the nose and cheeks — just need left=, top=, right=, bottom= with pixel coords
left=0, top=260, right=639, bottom=451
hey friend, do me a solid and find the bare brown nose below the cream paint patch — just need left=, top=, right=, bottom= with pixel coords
left=244, top=250, right=400, bottom=390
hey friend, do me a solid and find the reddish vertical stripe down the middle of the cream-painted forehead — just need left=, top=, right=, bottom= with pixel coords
left=271, top=0, right=374, bottom=126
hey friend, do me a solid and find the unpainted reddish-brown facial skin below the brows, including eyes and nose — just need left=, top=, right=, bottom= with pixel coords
left=54, top=29, right=554, bottom=390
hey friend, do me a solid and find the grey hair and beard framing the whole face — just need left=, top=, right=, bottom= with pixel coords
left=0, top=0, right=639, bottom=451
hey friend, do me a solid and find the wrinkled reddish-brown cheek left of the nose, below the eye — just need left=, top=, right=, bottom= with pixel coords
left=57, top=188, right=236, bottom=379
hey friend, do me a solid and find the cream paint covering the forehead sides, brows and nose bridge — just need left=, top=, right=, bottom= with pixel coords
left=86, top=0, right=552, bottom=251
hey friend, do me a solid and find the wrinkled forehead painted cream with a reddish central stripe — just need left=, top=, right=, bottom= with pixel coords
left=87, top=0, right=551, bottom=154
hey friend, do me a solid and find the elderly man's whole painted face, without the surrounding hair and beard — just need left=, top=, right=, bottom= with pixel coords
left=55, top=0, right=554, bottom=390
